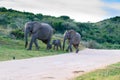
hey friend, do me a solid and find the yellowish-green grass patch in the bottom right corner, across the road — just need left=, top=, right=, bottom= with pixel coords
left=74, top=62, right=120, bottom=80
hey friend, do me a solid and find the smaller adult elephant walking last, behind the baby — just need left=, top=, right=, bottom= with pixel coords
left=63, top=30, right=81, bottom=53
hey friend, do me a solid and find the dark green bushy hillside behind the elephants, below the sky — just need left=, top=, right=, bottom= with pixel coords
left=0, top=7, right=120, bottom=49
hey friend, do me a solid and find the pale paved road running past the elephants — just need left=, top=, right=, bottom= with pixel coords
left=0, top=49, right=120, bottom=80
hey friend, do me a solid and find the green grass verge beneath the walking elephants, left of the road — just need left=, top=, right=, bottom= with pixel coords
left=0, top=36, right=65, bottom=61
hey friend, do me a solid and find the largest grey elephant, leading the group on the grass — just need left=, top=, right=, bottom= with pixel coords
left=24, top=21, right=53, bottom=50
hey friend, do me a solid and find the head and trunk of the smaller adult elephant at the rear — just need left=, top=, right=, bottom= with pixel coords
left=63, top=30, right=76, bottom=50
